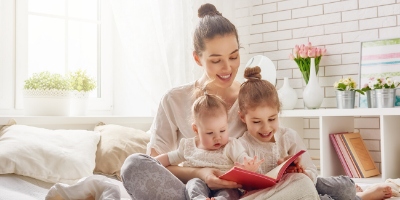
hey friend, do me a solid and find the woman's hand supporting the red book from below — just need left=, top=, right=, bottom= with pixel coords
left=198, top=168, right=242, bottom=190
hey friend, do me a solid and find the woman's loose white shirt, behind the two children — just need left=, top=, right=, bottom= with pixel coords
left=146, top=82, right=247, bottom=155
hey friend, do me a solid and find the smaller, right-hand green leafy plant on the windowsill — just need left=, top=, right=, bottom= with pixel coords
left=68, top=69, right=97, bottom=92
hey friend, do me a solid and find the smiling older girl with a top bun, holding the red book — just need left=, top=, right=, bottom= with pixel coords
left=238, top=67, right=391, bottom=200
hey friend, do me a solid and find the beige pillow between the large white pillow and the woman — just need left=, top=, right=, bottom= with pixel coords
left=94, top=122, right=150, bottom=180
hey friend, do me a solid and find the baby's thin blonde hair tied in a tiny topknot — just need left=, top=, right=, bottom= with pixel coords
left=192, top=82, right=228, bottom=122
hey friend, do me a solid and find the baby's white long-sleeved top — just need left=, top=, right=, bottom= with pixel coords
left=168, top=137, right=250, bottom=173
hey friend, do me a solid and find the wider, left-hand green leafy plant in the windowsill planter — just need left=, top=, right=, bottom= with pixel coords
left=24, top=71, right=71, bottom=90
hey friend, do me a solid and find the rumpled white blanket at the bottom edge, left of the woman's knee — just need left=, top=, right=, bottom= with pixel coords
left=46, top=175, right=130, bottom=200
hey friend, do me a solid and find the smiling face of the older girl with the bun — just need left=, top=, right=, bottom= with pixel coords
left=239, top=106, right=279, bottom=142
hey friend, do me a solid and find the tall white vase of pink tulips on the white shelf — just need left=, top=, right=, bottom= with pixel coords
left=289, top=42, right=326, bottom=109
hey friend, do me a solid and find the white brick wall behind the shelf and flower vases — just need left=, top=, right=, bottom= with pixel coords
left=231, top=0, right=400, bottom=173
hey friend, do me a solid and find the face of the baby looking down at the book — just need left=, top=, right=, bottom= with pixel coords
left=193, top=114, right=229, bottom=150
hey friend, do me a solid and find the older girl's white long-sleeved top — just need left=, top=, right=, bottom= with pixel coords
left=238, top=127, right=318, bottom=184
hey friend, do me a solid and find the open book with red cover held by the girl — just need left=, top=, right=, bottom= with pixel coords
left=219, top=150, right=306, bottom=190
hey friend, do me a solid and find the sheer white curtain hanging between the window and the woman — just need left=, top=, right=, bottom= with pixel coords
left=110, top=0, right=195, bottom=116
